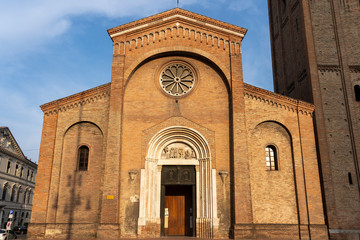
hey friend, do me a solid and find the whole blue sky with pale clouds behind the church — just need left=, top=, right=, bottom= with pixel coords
left=0, top=0, right=273, bottom=162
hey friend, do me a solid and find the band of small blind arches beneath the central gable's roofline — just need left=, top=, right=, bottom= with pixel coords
left=114, top=23, right=240, bottom=55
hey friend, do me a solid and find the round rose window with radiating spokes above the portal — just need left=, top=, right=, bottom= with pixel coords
left=160, top=63, right=195, bottom=96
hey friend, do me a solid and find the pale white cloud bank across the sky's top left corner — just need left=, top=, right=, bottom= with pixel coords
left=0, top=0, right=193, bottom=58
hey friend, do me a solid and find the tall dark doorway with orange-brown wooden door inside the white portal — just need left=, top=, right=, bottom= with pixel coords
left=161, top=166, right=196, bottom=236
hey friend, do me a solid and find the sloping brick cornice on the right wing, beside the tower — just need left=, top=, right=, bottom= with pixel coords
left=244, top=83, right=315, bottom=116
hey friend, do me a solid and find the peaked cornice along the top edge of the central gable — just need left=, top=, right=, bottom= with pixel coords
left=108, top=8, right=247, bottom=37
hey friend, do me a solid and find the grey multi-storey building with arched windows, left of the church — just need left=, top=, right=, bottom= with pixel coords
left=0, top=127, right=37, bottom=228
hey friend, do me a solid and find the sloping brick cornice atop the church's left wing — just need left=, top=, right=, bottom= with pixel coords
left=40, top=83, right=111, bottom=115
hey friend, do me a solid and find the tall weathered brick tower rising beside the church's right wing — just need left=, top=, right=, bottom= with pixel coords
left=268, top=0, right=360, bottom=239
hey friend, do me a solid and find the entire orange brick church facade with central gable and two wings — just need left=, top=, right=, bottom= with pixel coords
left=29, top=8, right=328, bottom=240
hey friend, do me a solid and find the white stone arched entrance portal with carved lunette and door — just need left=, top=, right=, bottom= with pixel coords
left=138, top=126, right=218, bottom=238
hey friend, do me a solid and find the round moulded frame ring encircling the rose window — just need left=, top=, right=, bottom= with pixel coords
left=156, top=60, right=199, bottom=99
